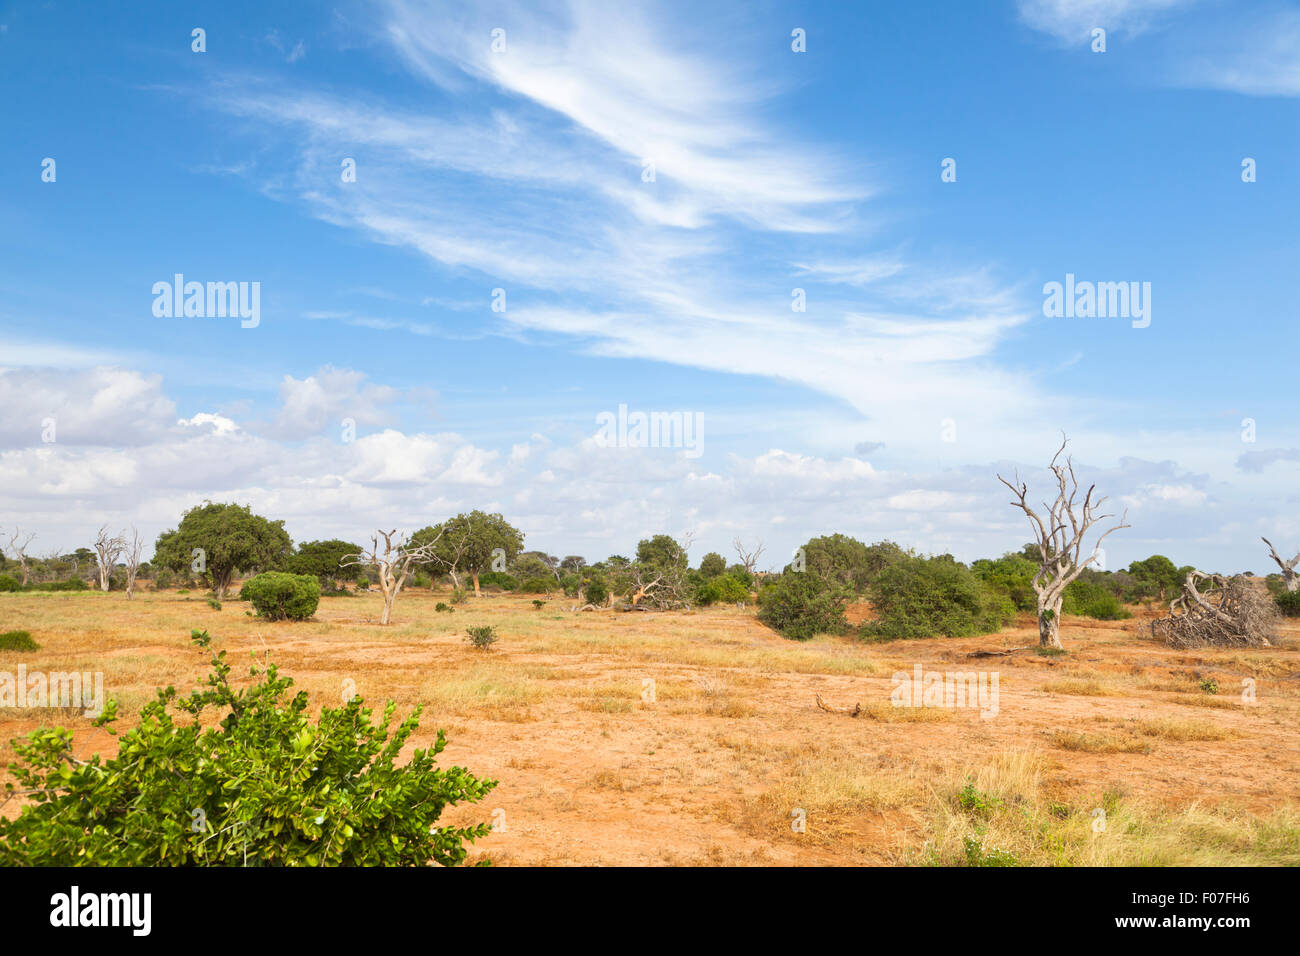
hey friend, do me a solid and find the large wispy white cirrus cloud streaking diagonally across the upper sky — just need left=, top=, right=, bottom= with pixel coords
left=197, top=1, right=1050, bottom=463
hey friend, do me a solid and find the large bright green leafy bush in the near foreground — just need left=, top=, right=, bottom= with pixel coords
left=0, top=629, right=497, bottom=866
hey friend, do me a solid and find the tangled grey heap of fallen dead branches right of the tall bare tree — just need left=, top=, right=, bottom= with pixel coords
left=1151, top=571, right=1278, bottom=649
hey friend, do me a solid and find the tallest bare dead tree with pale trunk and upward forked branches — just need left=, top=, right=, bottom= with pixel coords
left=997, top=436, right=1130, bottom=648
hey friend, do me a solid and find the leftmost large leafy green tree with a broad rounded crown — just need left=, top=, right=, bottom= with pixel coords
left=153, top=501, right=294, bottom=601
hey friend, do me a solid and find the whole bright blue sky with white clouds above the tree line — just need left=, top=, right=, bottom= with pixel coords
left=0, top=0, right=1300, bottom=570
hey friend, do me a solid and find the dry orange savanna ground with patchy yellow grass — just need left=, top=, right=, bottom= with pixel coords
left=0, top=592, right=1300, bottom=865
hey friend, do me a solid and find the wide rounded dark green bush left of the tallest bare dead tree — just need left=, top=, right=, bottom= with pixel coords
left=862, top=557, right=1015, bottom=640
